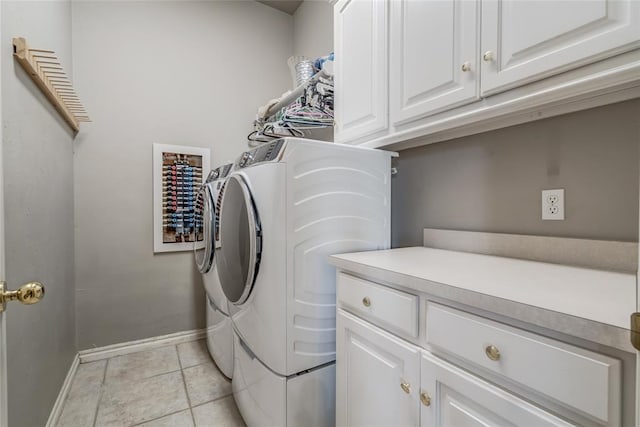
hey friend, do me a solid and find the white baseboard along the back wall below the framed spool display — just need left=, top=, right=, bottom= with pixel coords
left=78, top=329, right=206, bottom=363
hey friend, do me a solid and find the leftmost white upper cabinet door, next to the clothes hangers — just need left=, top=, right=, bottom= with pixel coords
left=334, top=0, right=388, bottom=142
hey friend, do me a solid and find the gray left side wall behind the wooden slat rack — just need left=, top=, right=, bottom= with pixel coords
left=0, top=1, right=76, bottom=427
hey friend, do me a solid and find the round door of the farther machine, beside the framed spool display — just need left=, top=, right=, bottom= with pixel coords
left=193, top=184, right=216, bottom=274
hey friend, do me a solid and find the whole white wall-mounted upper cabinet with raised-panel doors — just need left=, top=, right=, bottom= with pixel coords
left=334, top=0, right=640, bottom=149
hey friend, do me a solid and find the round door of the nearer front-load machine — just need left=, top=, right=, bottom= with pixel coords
left=215, top=175, right=262, bottom=305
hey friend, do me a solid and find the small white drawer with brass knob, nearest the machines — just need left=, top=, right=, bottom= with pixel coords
left=338, top=273, right=418, bottom=337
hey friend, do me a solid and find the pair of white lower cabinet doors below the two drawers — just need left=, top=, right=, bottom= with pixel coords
left=336, top=310, right=574, bottom=427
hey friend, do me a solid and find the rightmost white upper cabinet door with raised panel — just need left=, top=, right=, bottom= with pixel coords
left=481, top=0, right=640, bottom=95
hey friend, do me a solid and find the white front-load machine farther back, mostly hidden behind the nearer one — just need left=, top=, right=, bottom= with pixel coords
left=194, top=164, right=238, bottom=378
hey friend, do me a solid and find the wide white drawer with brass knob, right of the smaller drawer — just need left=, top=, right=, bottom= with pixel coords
left=426, top=302, right=621, bottom=425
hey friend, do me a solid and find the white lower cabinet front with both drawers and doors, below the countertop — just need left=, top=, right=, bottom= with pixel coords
left=336, top=272, right=621, bottom=427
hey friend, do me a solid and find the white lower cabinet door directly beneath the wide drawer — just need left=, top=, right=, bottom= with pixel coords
left=420, top=351, right=574, bottom=427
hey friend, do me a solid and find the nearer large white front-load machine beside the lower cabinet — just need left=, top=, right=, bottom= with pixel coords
left=216, top=138, right=394, bottom=426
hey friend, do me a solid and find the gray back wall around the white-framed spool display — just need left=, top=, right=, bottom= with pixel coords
left=73, top=1, right=293, bottom=349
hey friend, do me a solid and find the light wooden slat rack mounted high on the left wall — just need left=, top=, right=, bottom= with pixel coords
left=13, top=37, right=91, bottom=132
